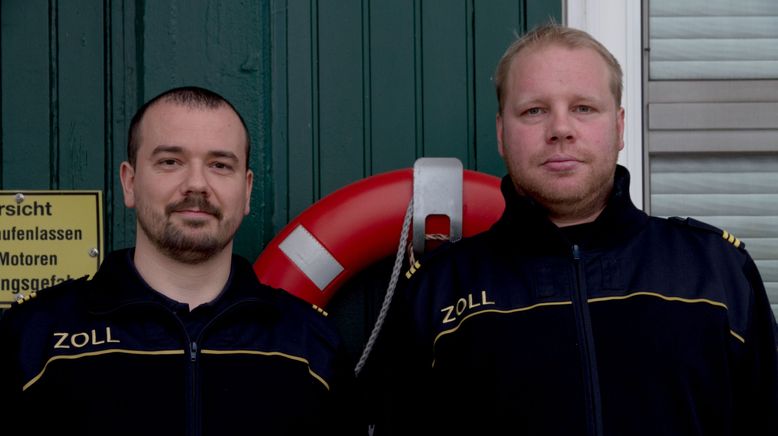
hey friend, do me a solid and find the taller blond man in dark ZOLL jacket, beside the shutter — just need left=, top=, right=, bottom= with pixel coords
left=376, top=24, right=778, bottom=436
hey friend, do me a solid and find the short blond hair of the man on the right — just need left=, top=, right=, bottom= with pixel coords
left=494, top=22, right=623, bottom=114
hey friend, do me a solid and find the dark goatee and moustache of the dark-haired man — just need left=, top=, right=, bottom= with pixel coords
left=137, top=194, right=238, bottom=264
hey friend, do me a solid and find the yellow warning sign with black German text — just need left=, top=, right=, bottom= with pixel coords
left=0, top=191, right=103, bottom=307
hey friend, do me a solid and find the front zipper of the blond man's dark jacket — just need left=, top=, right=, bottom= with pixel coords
left=572, top=244, right=602, bottom=436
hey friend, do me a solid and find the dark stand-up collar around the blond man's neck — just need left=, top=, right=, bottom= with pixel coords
left=493, top=165, right=648, bottom=254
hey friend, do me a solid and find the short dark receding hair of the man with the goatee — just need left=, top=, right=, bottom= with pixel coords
left=127, top=86, right=251, bottom=170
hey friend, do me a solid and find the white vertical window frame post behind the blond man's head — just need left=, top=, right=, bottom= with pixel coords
left=562, top=0, right=644, bottom=208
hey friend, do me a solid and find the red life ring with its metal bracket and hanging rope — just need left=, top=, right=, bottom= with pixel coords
left=254, top=158, right=505, bottom=373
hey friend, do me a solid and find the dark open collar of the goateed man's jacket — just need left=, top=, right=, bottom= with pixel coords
left=87, top=248, right=275, bottom=313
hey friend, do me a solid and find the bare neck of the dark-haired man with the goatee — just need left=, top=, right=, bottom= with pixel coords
left=133, top=233, right=232, bottom=310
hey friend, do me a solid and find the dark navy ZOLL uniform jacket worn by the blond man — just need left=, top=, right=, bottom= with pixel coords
left=374, top=167, right=778, bottom=436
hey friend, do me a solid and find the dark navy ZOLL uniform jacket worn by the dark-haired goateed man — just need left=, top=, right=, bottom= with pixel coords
left=0, top=251, right=356, bottom=436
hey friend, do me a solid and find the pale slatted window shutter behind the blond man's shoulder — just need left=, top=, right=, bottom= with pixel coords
left=645, top=0, right=778, bottom=316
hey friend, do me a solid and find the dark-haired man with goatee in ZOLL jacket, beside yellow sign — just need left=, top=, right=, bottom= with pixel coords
left=0, top=87, right=349, bottom=435
